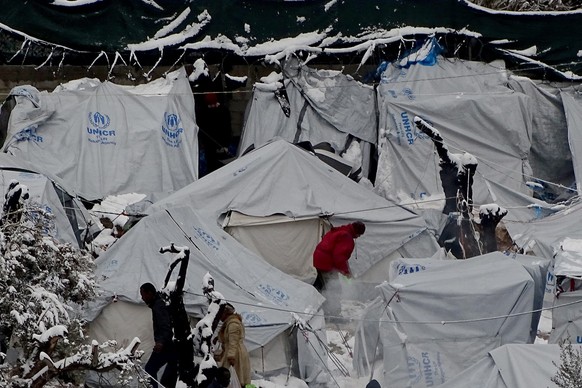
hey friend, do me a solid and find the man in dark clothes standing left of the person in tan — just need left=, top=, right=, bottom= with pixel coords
left=139, top=283, right=178, bottom=388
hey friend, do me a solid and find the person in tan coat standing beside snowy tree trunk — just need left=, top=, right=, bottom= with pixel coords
left=214, top=303, right=251, bottom=387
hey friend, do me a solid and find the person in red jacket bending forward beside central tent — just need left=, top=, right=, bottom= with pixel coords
left=313, top=221, right=366, bottom=315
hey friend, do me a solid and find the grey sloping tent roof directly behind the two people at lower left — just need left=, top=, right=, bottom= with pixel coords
left=87, top=207, right=323, bottom=350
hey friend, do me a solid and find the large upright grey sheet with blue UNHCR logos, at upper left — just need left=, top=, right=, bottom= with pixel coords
left=3, top=68, right=198, bottom=200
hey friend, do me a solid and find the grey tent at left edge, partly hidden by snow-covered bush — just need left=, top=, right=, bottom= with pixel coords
left=0, top=153, right=91, bottom=248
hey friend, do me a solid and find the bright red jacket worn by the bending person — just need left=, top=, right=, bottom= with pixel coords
left=313, top=224, right=356, bottom=275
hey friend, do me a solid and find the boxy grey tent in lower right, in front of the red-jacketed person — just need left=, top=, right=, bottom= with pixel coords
left=354, top=254, right=547, bottom=387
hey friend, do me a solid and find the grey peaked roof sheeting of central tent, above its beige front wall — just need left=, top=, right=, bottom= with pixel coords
left=150, top=140, right=438, bottom=278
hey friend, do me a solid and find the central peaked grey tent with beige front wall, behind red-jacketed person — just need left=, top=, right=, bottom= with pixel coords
left=151, top=140, right=438, bottom=284
